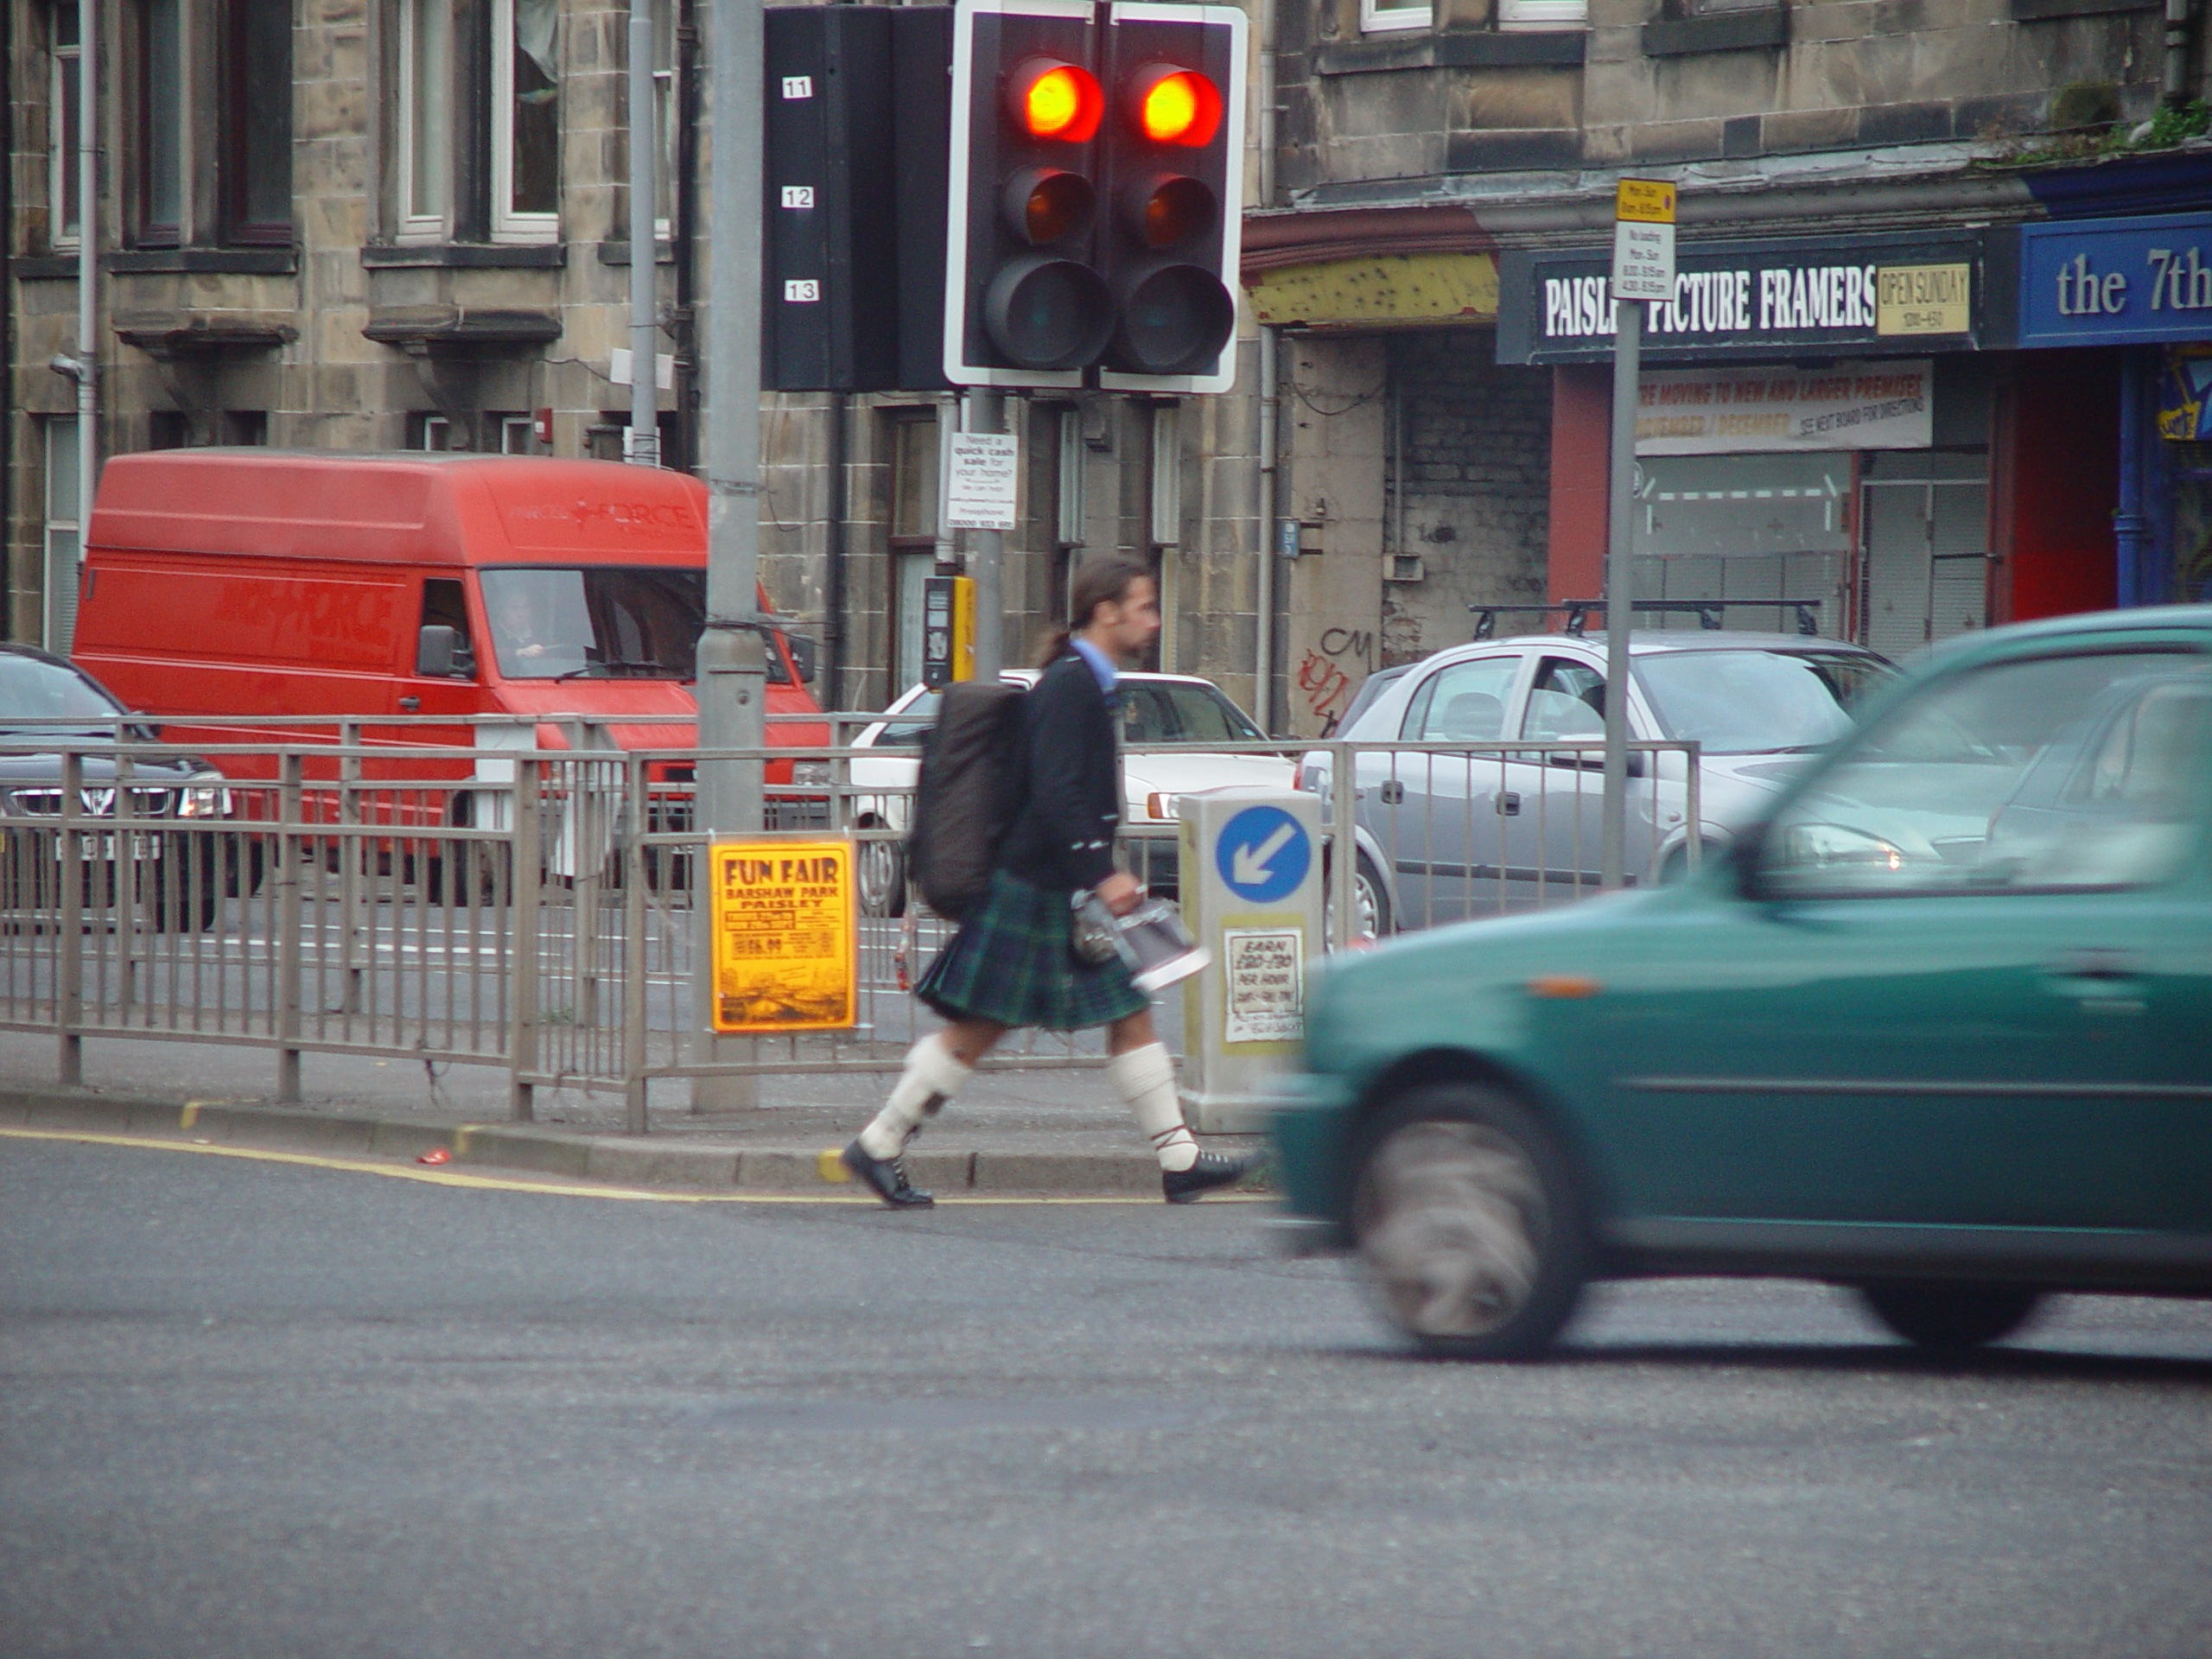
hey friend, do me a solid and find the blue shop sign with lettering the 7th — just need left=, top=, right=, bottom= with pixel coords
left=2019, top=213, right=2212, bottom=345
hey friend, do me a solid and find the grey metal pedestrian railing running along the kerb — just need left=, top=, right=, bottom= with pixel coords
left=0, top=716, right=1701, bottom=1133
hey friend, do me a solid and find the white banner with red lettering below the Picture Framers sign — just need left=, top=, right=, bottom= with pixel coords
left=1637, top=359, right=1936, bottom=455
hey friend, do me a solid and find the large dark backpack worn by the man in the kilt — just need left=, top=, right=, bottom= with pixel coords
left=907, top=679, right=1028, bottom=920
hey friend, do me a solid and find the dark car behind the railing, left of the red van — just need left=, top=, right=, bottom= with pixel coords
left=0, top=644, right=237, bottom=929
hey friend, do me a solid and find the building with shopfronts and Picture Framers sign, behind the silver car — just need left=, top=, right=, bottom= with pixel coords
left=1245, top=0, right=2212, bottom=721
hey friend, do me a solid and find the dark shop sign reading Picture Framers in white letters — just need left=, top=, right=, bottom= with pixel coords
left=1497, top=237, right=1984, bottom=363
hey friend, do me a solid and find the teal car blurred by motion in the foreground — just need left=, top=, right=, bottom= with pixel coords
left=1274, top=606, right=2212, bottom=1358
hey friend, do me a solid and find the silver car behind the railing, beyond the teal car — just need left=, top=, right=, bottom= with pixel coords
left=1299, top=628, right=1896, bottom=933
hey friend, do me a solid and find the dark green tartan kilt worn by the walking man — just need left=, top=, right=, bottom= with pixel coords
left=913, top=869, right=1150, bottom=1031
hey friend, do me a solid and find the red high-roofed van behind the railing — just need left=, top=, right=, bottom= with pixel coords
left=75, top=449, right=830, bottom=818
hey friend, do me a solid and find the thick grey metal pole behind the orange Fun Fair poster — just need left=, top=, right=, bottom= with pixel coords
left=690, top=0, right=767, bottom=1110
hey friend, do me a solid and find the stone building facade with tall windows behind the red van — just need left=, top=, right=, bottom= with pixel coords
left=0, top=0, right=1259, bottom=725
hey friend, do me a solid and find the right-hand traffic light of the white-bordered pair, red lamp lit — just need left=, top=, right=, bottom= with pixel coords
left=1099, top=0, right=1245, bottom=391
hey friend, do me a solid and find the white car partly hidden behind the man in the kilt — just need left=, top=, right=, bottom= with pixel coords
left=849, top=668, right=1296, bottom=916
